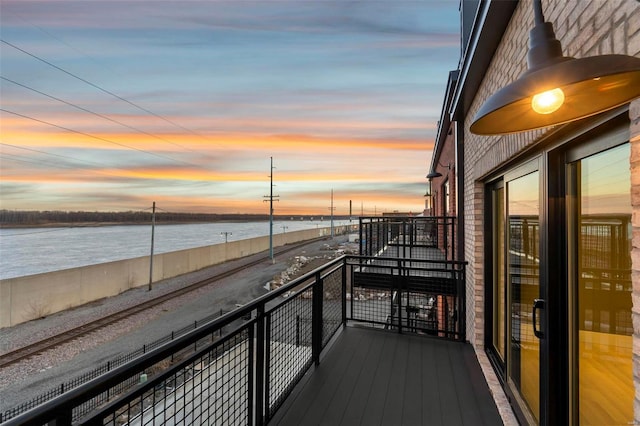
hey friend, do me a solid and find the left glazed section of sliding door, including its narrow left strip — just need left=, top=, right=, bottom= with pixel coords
left=489, top=160, right=541, bottom=422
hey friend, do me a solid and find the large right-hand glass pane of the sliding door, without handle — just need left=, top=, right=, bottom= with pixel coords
left=569, top=144, right=634, bottom=425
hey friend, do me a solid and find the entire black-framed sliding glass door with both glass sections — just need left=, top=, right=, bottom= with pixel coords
left=485, top=113, right=638, bottom=425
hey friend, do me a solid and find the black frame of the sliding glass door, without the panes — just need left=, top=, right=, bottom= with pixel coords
left=484, top=105, right=630, bottom=425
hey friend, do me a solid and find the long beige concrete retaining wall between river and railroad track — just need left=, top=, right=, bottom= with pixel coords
left=0, top=226, right=356, bottom=328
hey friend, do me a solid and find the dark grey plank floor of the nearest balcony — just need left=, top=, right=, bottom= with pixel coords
left=269, top=327, right=502, bottom=426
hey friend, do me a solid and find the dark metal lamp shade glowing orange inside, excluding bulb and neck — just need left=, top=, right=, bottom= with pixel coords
left=471, top=55, right=640, bottom=135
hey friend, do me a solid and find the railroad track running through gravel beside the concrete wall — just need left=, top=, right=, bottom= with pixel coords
left=0, top=237, right=325, bottom=369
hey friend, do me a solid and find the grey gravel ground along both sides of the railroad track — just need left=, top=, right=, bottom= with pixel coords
left=0, top=236, right=353, bottom=412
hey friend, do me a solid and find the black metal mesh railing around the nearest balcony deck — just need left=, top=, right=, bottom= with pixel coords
left=6, top=256, right=465, bottom=425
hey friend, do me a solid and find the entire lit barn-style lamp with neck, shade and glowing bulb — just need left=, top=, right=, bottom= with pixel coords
left=471, top=0, right=640, bottom=135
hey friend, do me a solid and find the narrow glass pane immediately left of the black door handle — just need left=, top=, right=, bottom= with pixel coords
left=505, top=171, right=540, bottom=421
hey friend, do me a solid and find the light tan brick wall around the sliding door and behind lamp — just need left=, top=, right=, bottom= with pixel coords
left=464, top=0, right=640, bottom=356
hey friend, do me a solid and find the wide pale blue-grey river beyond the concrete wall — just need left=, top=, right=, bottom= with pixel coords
left=0, top=220, right=358, bottom=279
